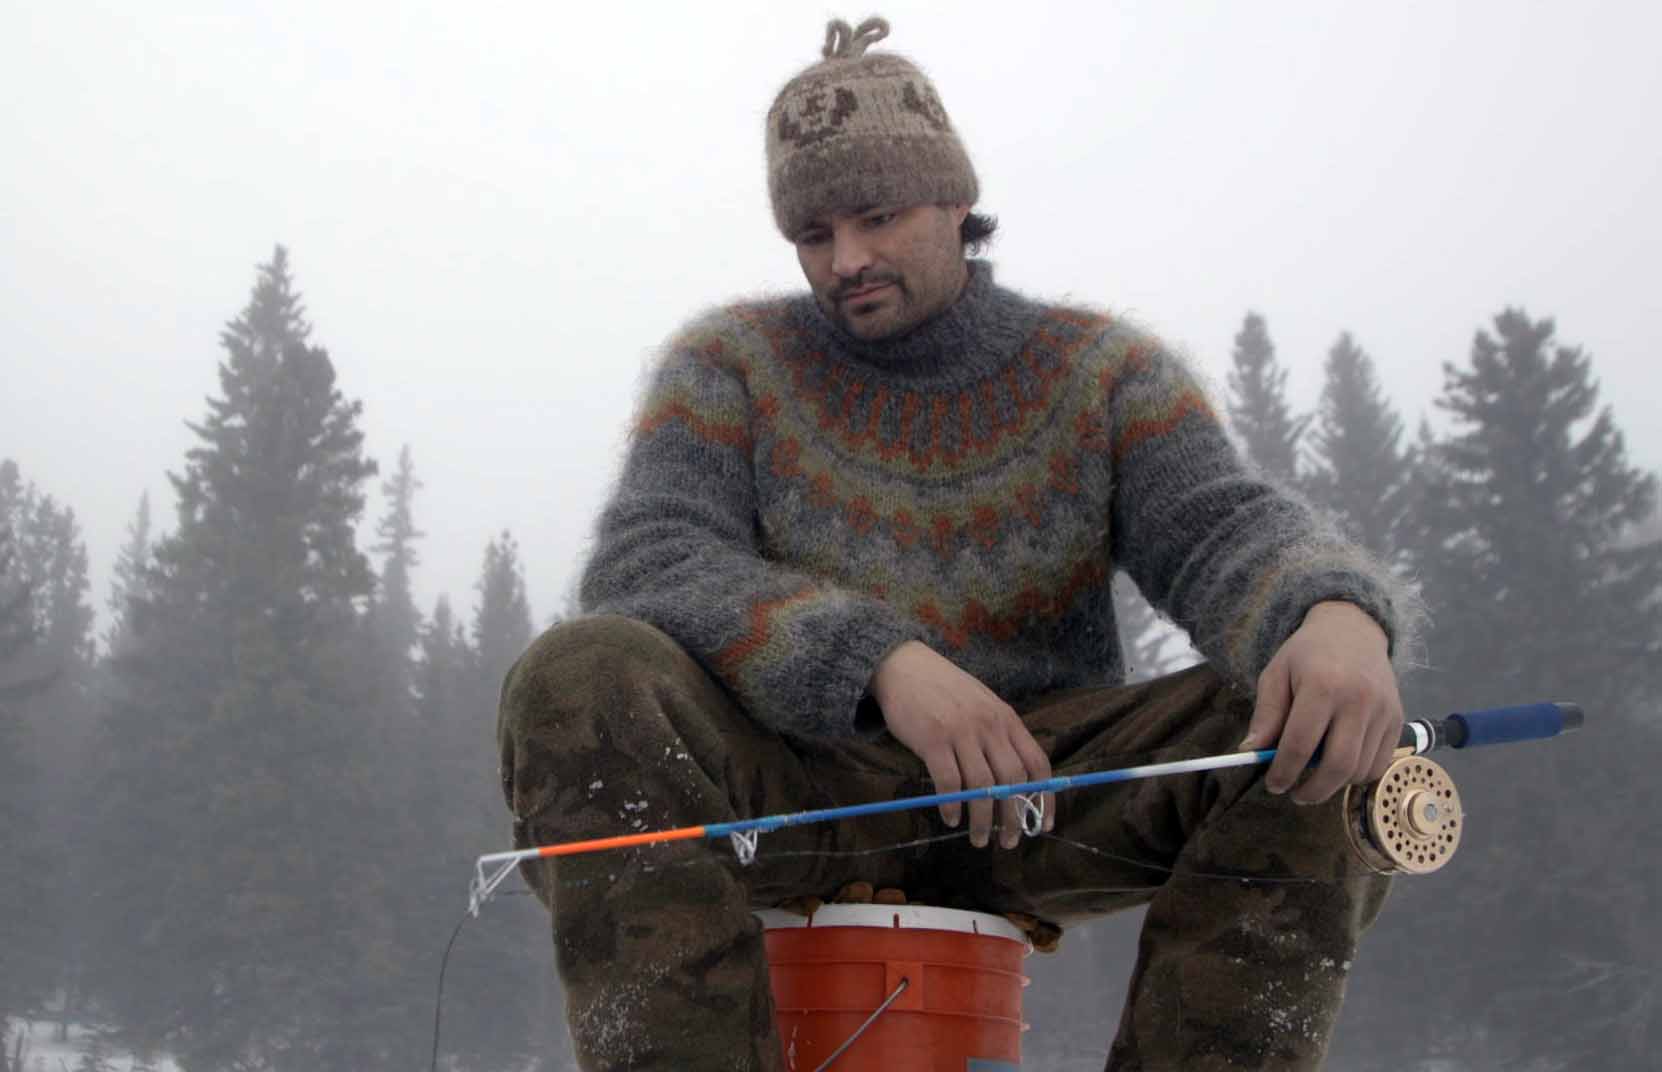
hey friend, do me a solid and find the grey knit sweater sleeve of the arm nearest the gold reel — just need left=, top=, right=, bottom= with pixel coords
left=1107, top=339, right=1416, bottom=686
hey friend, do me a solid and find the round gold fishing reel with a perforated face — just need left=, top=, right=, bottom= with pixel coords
left=1345, top=755, right=1466, bottom=874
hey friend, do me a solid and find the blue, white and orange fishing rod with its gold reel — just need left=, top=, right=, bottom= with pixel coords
left=467, top=703, right=1586, bottom=916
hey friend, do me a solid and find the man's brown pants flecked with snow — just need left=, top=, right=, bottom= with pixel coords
left=499, top=618, right=1388, bottom=1072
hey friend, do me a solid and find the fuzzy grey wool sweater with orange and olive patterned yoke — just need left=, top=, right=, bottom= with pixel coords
left=580, top=261, right=1401, bottom=735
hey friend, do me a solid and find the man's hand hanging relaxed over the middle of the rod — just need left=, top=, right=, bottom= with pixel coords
left=871, top=640, right=1055, bottom=849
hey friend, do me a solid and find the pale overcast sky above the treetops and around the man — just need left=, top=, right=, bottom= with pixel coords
left=0, top=0, right=1662, bottom=623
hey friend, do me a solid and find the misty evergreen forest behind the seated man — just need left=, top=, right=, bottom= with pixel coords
left=0, top=248, right=1662, bottom=1072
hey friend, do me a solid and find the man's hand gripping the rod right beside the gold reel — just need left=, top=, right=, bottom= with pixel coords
left=1240, top=602, right=1403, bottom=804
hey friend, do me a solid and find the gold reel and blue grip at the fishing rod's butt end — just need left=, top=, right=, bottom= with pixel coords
left=1345, top=703, right=1584, bottom=874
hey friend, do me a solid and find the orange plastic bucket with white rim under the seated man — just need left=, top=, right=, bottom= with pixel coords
left=756, top=904, right=1029, bottom=1072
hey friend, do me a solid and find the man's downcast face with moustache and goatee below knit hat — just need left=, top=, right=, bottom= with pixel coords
left=796, top=204, right=969, bottom=341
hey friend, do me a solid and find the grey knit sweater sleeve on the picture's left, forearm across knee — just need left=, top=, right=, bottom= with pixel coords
left=578, top=314, right=924, bottom=736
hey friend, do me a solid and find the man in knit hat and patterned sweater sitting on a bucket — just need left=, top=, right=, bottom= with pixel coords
left=499, top=20, right=1408, bottom=1070
